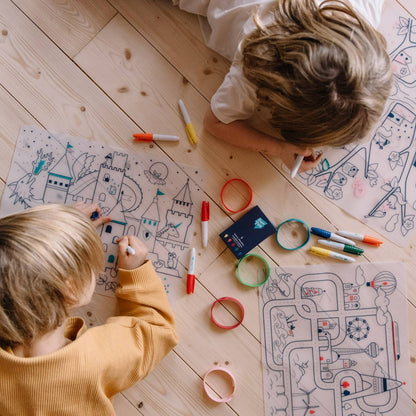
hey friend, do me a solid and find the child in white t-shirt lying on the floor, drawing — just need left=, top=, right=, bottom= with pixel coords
left=176, top=0, right=392, bottom=171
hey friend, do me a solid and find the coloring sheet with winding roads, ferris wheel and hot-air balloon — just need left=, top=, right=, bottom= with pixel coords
left=260, top=263, right=412, bottom=416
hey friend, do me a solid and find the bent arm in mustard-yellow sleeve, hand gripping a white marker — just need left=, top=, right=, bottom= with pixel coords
left=102, top=236, right=178, bottom=392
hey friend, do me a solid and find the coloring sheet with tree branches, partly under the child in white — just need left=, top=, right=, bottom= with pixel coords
left=299, top=2, right=416, bottom=245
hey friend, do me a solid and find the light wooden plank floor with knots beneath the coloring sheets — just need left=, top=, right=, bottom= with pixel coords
left=0, top=0, right=416, bottom=416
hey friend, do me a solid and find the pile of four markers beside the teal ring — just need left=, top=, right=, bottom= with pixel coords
left=310, top=227, right=383, bottom=263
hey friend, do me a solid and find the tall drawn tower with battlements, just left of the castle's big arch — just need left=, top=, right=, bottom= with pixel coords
left=92, top=152, right=127, bottom=208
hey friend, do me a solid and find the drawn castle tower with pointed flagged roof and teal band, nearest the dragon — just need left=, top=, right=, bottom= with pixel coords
left=42, top=143, right=72, bottom=204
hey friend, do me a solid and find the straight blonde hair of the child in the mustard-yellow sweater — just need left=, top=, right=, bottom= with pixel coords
left=0, top=204, right=103, bottom=348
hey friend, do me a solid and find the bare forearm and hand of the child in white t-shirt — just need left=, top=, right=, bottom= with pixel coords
left=204, top=108, right=320, bottom=172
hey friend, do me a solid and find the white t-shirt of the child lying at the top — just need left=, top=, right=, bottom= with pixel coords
left=174, top=0, right=384, bottom=124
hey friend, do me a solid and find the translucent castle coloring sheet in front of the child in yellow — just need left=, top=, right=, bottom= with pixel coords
left=0, top=126, right=202, bottom=300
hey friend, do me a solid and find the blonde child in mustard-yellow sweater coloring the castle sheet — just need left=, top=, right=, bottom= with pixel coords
left=0, top=204, right=177, bottom=416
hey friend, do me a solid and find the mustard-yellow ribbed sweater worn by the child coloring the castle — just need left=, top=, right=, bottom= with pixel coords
left=0, top=261, right=177, bottom=416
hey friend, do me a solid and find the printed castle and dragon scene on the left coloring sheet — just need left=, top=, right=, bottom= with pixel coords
left=9, top=138, right=194, bottom=291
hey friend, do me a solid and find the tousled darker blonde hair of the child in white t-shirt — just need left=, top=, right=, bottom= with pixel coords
left=241, top=0, right=392, bottom=147
